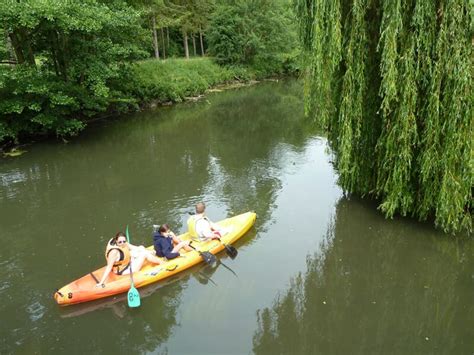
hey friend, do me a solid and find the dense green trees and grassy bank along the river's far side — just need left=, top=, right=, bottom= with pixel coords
left=0, top=0, right=298, bottom=147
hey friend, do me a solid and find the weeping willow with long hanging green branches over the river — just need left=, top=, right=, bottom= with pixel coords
left=295, top=0, right=474, bottom=232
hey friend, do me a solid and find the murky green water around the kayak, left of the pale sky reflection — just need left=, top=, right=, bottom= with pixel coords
left=0, top=80, right=314, bottom=353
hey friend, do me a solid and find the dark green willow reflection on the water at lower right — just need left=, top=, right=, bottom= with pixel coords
left=253, top=199, right=474, bottom=354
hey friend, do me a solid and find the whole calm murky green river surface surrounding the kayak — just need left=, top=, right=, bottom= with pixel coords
left=0, top=80, right=474, bottom=354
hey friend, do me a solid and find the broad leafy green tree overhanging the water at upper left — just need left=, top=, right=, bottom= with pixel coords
left=0, top=0, right=143, bottom=145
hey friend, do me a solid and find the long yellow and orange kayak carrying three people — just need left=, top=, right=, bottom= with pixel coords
left=54, top=212, right=257, bottom=305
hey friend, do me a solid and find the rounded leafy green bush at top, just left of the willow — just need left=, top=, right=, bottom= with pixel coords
left=207, top=0, right=296, bottom=73
